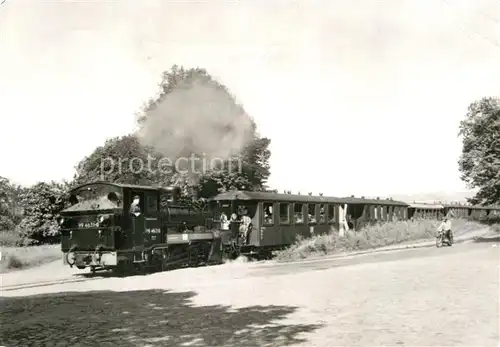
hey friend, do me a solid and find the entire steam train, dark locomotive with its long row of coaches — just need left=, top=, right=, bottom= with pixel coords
left=58, top=181, right=500, bottom=272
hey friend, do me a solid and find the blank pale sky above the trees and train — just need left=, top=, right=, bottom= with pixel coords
left=0, top=0, right=500, bottom=196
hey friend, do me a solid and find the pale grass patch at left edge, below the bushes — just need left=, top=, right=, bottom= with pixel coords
left=0, top=231, right=61, bottom=273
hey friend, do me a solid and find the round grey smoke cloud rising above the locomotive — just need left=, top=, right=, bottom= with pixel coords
left=138, top=81, right=254, bottom=182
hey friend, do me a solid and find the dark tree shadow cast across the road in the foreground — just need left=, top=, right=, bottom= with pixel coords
left=0, top=290, right=321, bottom=347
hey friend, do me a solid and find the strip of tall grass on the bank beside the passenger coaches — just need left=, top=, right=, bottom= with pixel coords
left=276, top=219, right=486, bottom=261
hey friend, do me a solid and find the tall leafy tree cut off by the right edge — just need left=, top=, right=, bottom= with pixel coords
left=458, top=97, right=500, bottom=205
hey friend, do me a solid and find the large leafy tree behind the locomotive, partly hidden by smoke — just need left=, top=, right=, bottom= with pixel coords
left=73, top=65, right=270, bottom=197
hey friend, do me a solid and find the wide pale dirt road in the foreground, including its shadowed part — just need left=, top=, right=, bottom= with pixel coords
left=0, top=243, right=500, bottom=347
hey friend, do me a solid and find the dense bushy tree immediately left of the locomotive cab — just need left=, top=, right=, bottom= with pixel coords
left=18, top=182, right=67, bottom=244
